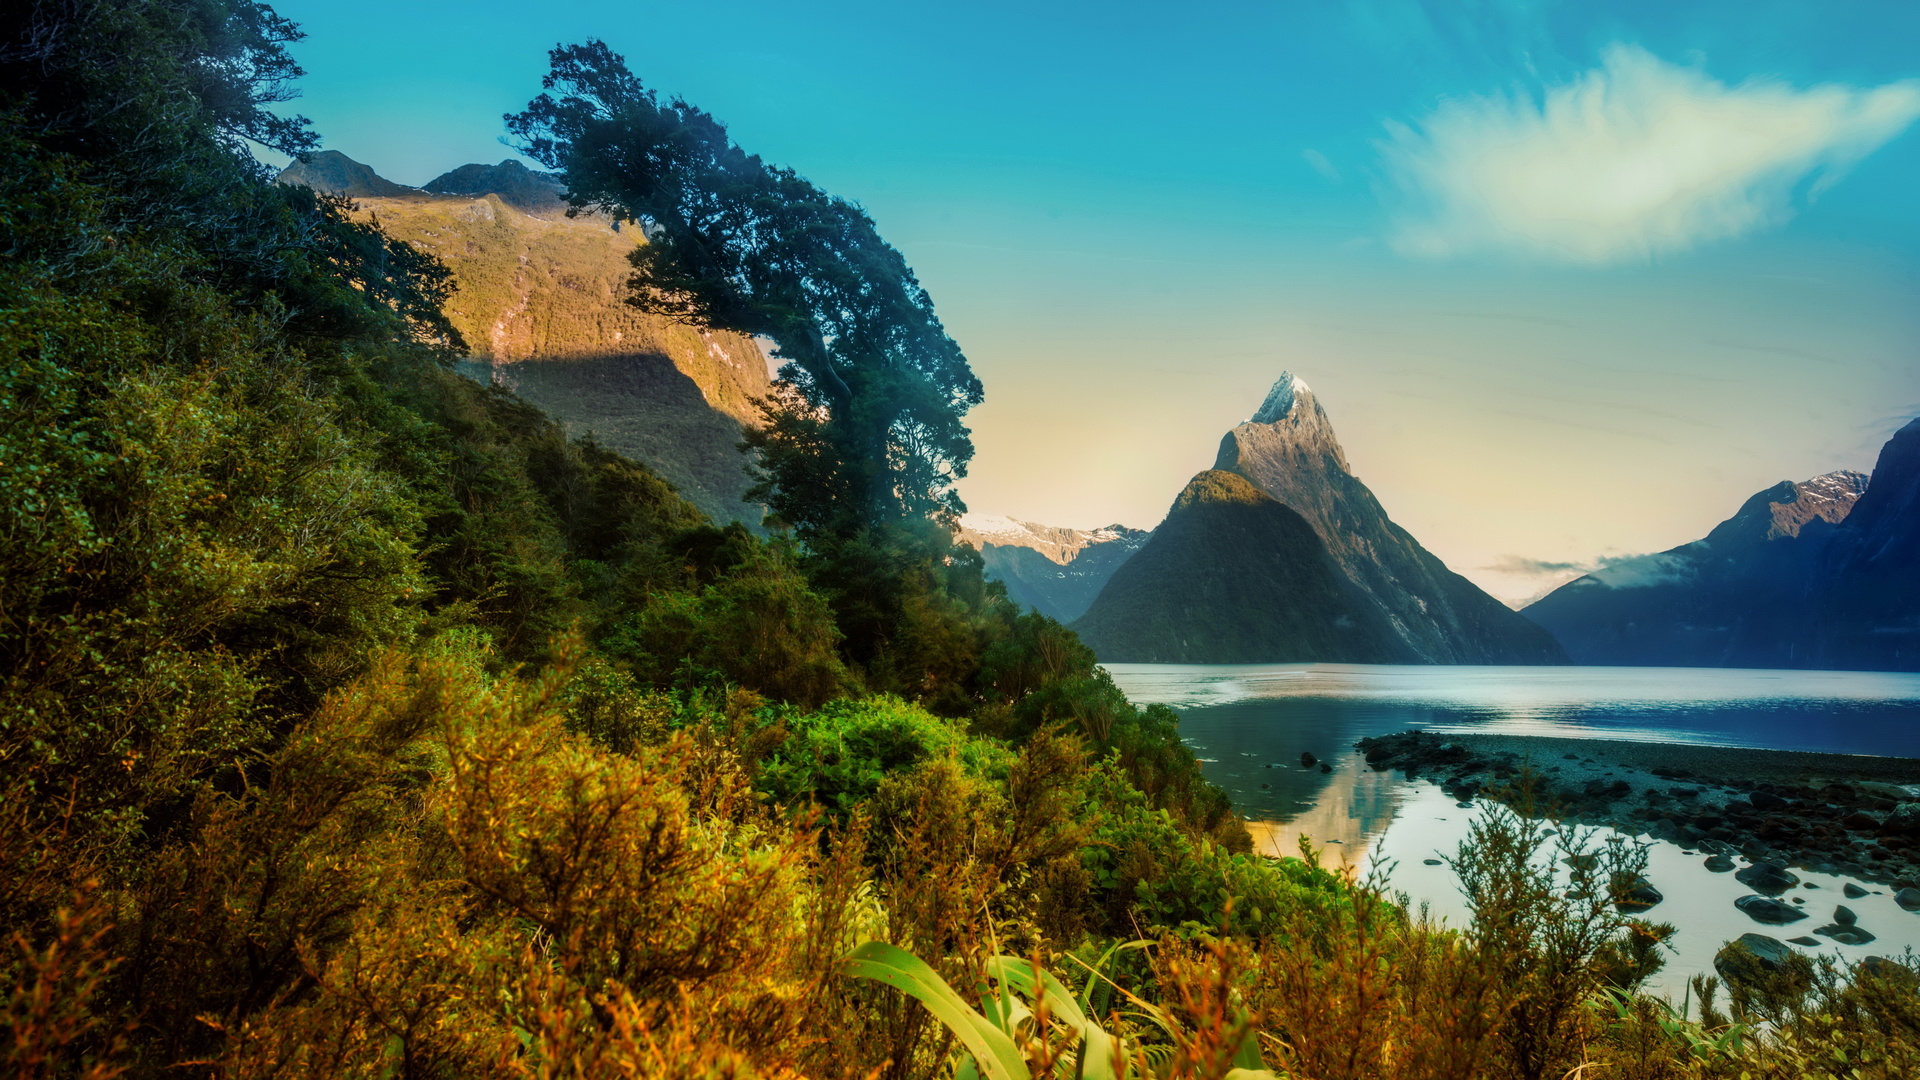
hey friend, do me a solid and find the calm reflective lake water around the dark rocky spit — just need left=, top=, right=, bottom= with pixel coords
left=1108, top=665, right=1920, bottom=990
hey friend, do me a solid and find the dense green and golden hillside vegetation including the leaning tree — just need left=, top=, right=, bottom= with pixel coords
left=0, top=0, right=1920, bottom=1080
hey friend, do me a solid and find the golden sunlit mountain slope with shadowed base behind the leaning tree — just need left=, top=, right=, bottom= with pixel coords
left=280, top=150, right=770, bottom=528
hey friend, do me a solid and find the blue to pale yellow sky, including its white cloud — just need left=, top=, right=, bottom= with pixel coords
left=263, top=0, right=1920, bottom=600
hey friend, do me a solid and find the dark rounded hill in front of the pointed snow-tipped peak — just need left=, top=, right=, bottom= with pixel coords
left=1073, top=469, right=1411, bottom=663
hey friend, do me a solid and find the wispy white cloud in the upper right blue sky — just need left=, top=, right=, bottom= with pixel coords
left=1380, top=46, right=1920, bottom=263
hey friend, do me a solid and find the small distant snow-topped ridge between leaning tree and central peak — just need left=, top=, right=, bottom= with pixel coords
left=960, top=513, right=1146, bottom=623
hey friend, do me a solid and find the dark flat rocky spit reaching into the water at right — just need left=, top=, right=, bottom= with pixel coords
left=1356, top=730, right=1920, bottom=887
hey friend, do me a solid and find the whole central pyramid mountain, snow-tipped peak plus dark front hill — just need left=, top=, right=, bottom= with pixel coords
left=1073, top=373, right=1565, bottom=663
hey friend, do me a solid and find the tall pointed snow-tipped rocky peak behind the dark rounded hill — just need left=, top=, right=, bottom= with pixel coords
left=1213, top=373, right=1565, bottom=663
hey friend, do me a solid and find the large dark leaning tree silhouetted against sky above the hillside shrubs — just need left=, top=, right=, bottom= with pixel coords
left=507, top=40, right=981, bottom=542
